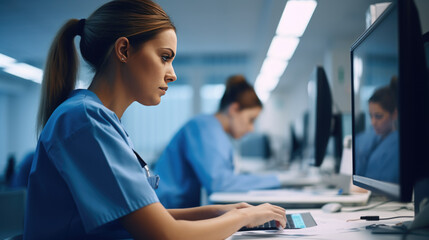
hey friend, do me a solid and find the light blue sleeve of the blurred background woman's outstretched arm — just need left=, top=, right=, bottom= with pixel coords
left=184, top=119, right=280, bottom=194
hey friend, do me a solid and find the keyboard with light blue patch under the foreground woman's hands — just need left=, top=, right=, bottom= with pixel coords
left=239, top=212, right=317, bottom=231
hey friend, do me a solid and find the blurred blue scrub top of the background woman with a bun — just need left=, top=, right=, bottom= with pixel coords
left=155, top=115, right=280, bottom=208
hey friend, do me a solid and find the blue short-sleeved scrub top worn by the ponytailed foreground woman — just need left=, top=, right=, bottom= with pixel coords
left=24, top=90, right=159, bottom=239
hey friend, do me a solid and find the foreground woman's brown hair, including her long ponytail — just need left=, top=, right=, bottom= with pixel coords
left=37, top=0, right=176, bottom=130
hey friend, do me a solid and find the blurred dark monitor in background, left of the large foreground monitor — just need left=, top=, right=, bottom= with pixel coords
left=306, top=66, right=342, bottom=172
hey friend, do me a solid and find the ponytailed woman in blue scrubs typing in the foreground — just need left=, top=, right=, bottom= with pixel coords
left=24, top=0, right=286, bottom=239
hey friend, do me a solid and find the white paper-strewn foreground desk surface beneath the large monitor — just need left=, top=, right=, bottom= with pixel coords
left=228, top=202, right=429, bottom=240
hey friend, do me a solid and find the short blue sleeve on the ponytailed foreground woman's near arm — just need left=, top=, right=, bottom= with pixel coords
left=49, top=124, right=159, bottom=232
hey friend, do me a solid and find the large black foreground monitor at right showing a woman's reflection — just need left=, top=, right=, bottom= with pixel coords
left=351, top=0, right=429, bottom=229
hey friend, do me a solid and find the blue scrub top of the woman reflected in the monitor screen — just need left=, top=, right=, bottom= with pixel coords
left=355, top=128, right=399, bottom=183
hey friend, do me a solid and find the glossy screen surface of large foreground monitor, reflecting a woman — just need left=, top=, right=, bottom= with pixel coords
left=352, top=1, right=399, bottom=195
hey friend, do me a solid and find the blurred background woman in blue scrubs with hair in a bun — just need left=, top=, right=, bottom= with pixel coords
left=155, top=75, right=281, bottom=208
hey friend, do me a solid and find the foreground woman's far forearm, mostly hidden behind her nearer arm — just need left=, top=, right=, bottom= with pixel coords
left=167, top=202, right=252, bottom=220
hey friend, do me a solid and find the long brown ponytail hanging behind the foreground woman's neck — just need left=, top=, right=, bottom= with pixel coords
left=37, top=19, right=82, bottom=132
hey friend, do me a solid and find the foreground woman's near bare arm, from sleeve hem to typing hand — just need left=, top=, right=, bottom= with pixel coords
left=121, top=203, right=286, bottom=240
